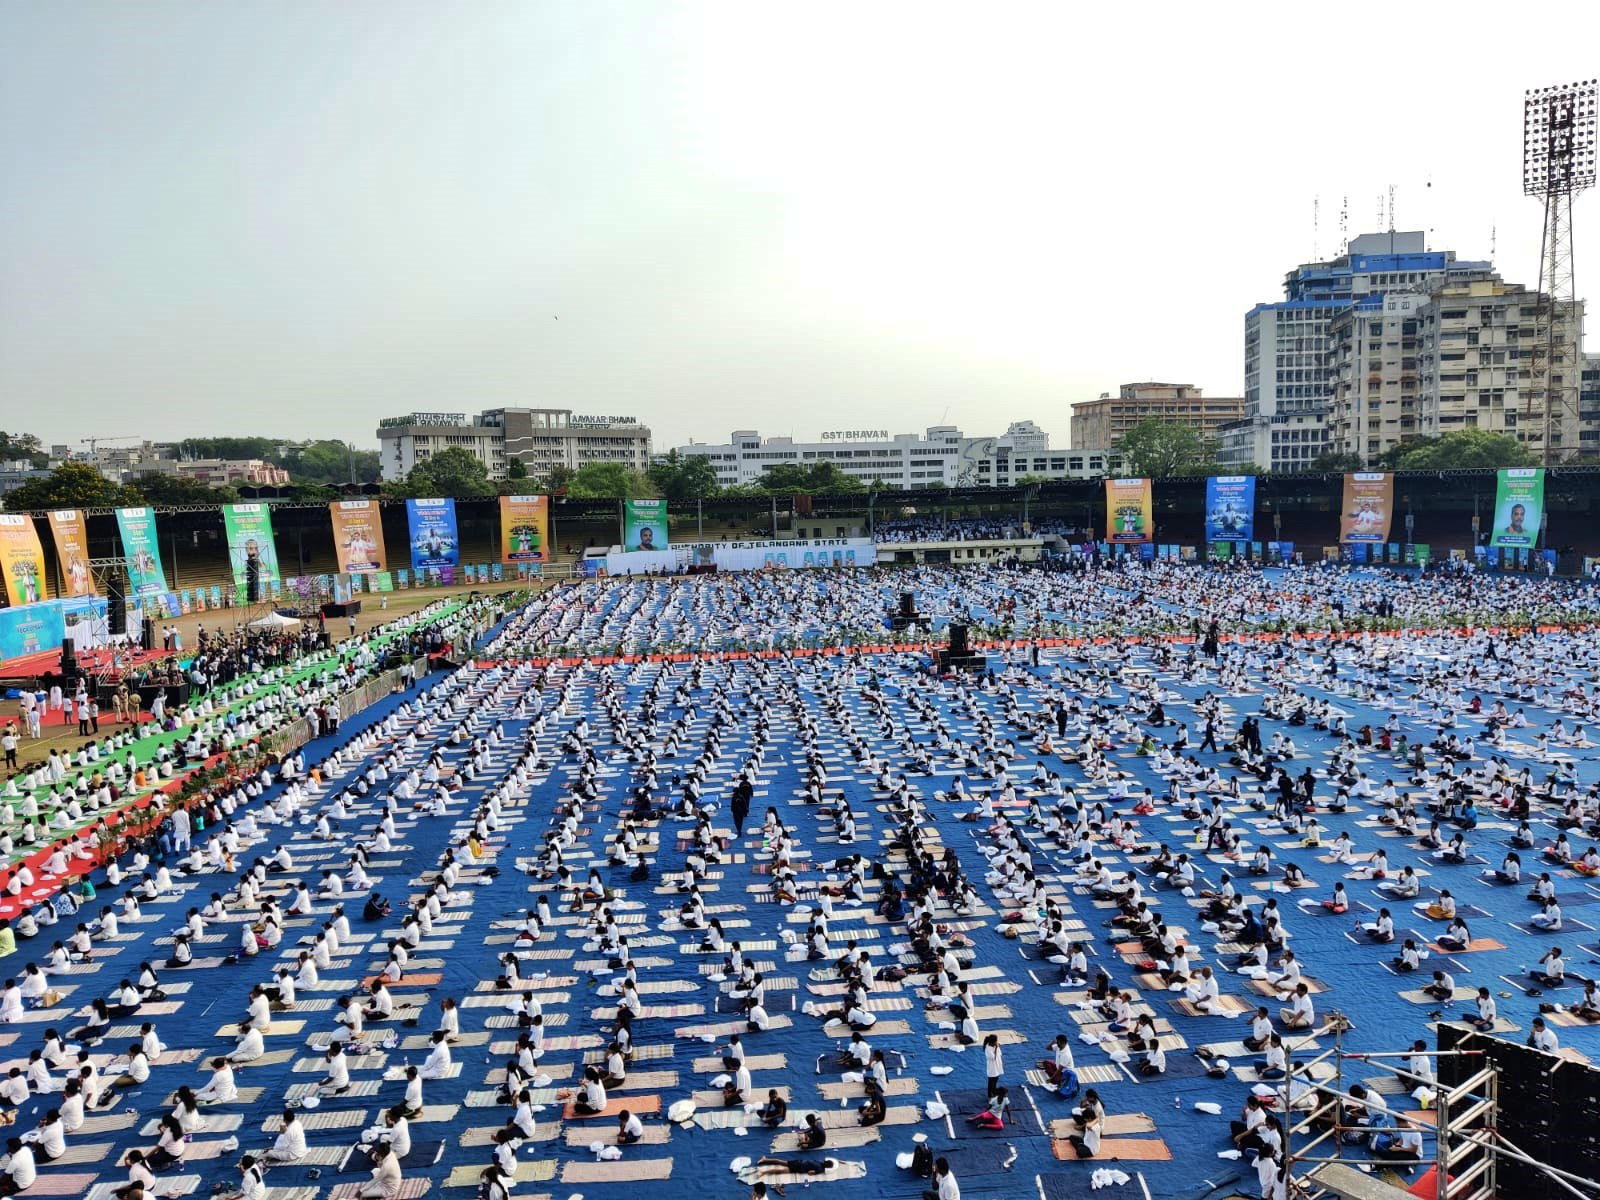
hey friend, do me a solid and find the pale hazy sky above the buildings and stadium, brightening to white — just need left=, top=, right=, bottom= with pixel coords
left=0, top=0, right=1600, bottom=450
